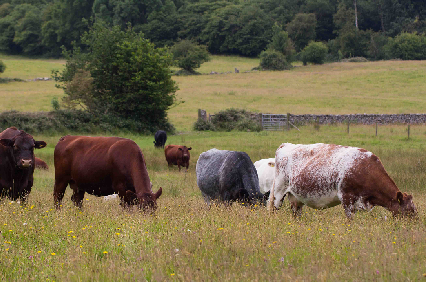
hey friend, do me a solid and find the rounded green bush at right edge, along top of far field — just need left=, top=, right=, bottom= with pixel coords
left=386, top=32, right=426, bottom=60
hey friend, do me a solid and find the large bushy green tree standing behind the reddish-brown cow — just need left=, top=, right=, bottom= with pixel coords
left=55, top=22, right=178, bottom=125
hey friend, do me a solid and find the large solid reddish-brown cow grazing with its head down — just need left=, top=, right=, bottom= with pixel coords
left=53, top=135, right=162, bottom=211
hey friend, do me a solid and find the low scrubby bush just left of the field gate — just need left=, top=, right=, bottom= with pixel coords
left=212, top=108, right=262, bottom=131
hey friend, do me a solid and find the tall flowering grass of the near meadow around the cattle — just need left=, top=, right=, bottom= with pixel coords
left=0, top=126, right=426, bottom=281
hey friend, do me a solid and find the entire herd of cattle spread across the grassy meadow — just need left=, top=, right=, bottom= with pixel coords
left=0, top=127, right=417, bottom=218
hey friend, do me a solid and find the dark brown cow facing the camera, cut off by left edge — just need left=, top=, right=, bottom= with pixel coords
left=0, top=127, right=46, bottom=203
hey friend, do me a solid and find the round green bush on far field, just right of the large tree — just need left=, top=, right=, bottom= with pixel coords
left=171, top=40, right=210, bottom=72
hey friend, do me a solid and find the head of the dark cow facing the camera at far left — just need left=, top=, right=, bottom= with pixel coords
left=0, top=132, right=46, bottom=169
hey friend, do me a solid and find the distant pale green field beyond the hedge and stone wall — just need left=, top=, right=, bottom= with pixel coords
left=0, top=56, right=426, bottom=131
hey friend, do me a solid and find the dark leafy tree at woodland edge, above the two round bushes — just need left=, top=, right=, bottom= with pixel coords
left=287, top=13, right=317, bottom=52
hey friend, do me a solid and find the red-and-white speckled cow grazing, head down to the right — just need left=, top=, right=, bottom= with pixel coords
left=268, top=143, right=416, bottom=219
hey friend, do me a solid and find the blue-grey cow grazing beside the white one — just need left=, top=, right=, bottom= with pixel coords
left=196, top=149, right=267, bottom=204
